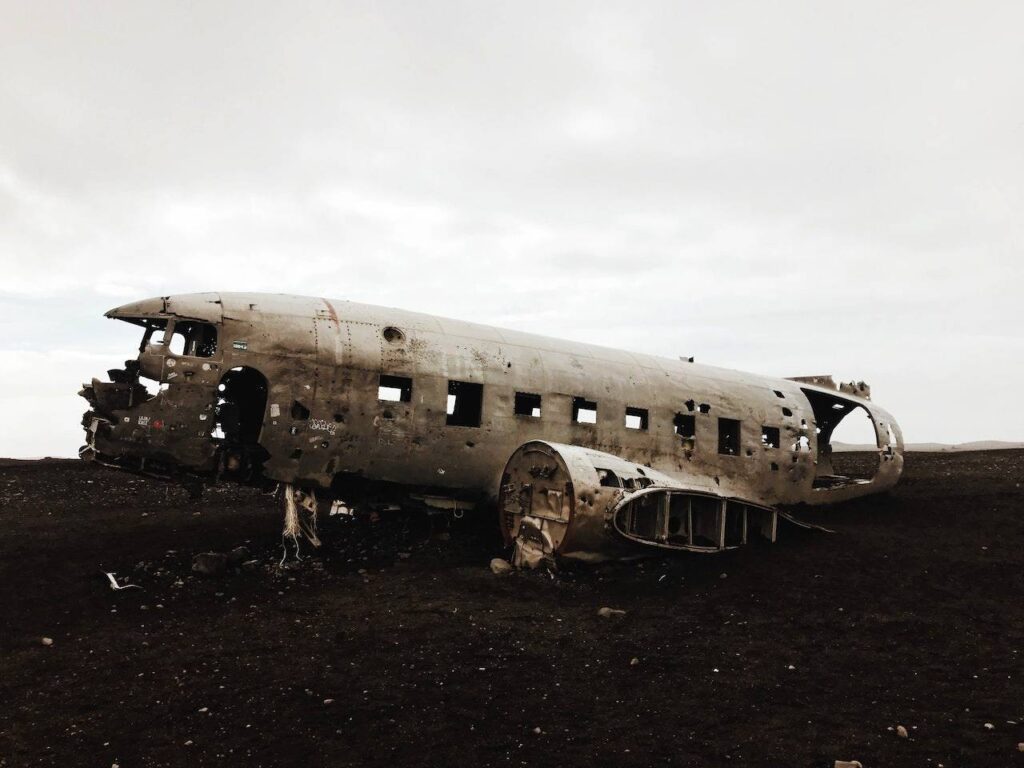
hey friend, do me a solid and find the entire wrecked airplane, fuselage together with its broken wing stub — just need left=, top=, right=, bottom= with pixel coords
left=82, top=293, right=903, bottom=561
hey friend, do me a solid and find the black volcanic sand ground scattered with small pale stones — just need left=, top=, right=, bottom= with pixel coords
left=0, top=451, right=1024, bottom=768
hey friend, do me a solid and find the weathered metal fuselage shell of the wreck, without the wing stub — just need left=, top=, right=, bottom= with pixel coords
left=83, top=293, right=903, bottom=512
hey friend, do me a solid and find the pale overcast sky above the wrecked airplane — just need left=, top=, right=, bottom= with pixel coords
left=0, top=0, right=1024, bottom=457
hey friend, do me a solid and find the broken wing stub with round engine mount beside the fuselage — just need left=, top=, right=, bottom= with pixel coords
left=499, top=440, right=778, bottom=566
